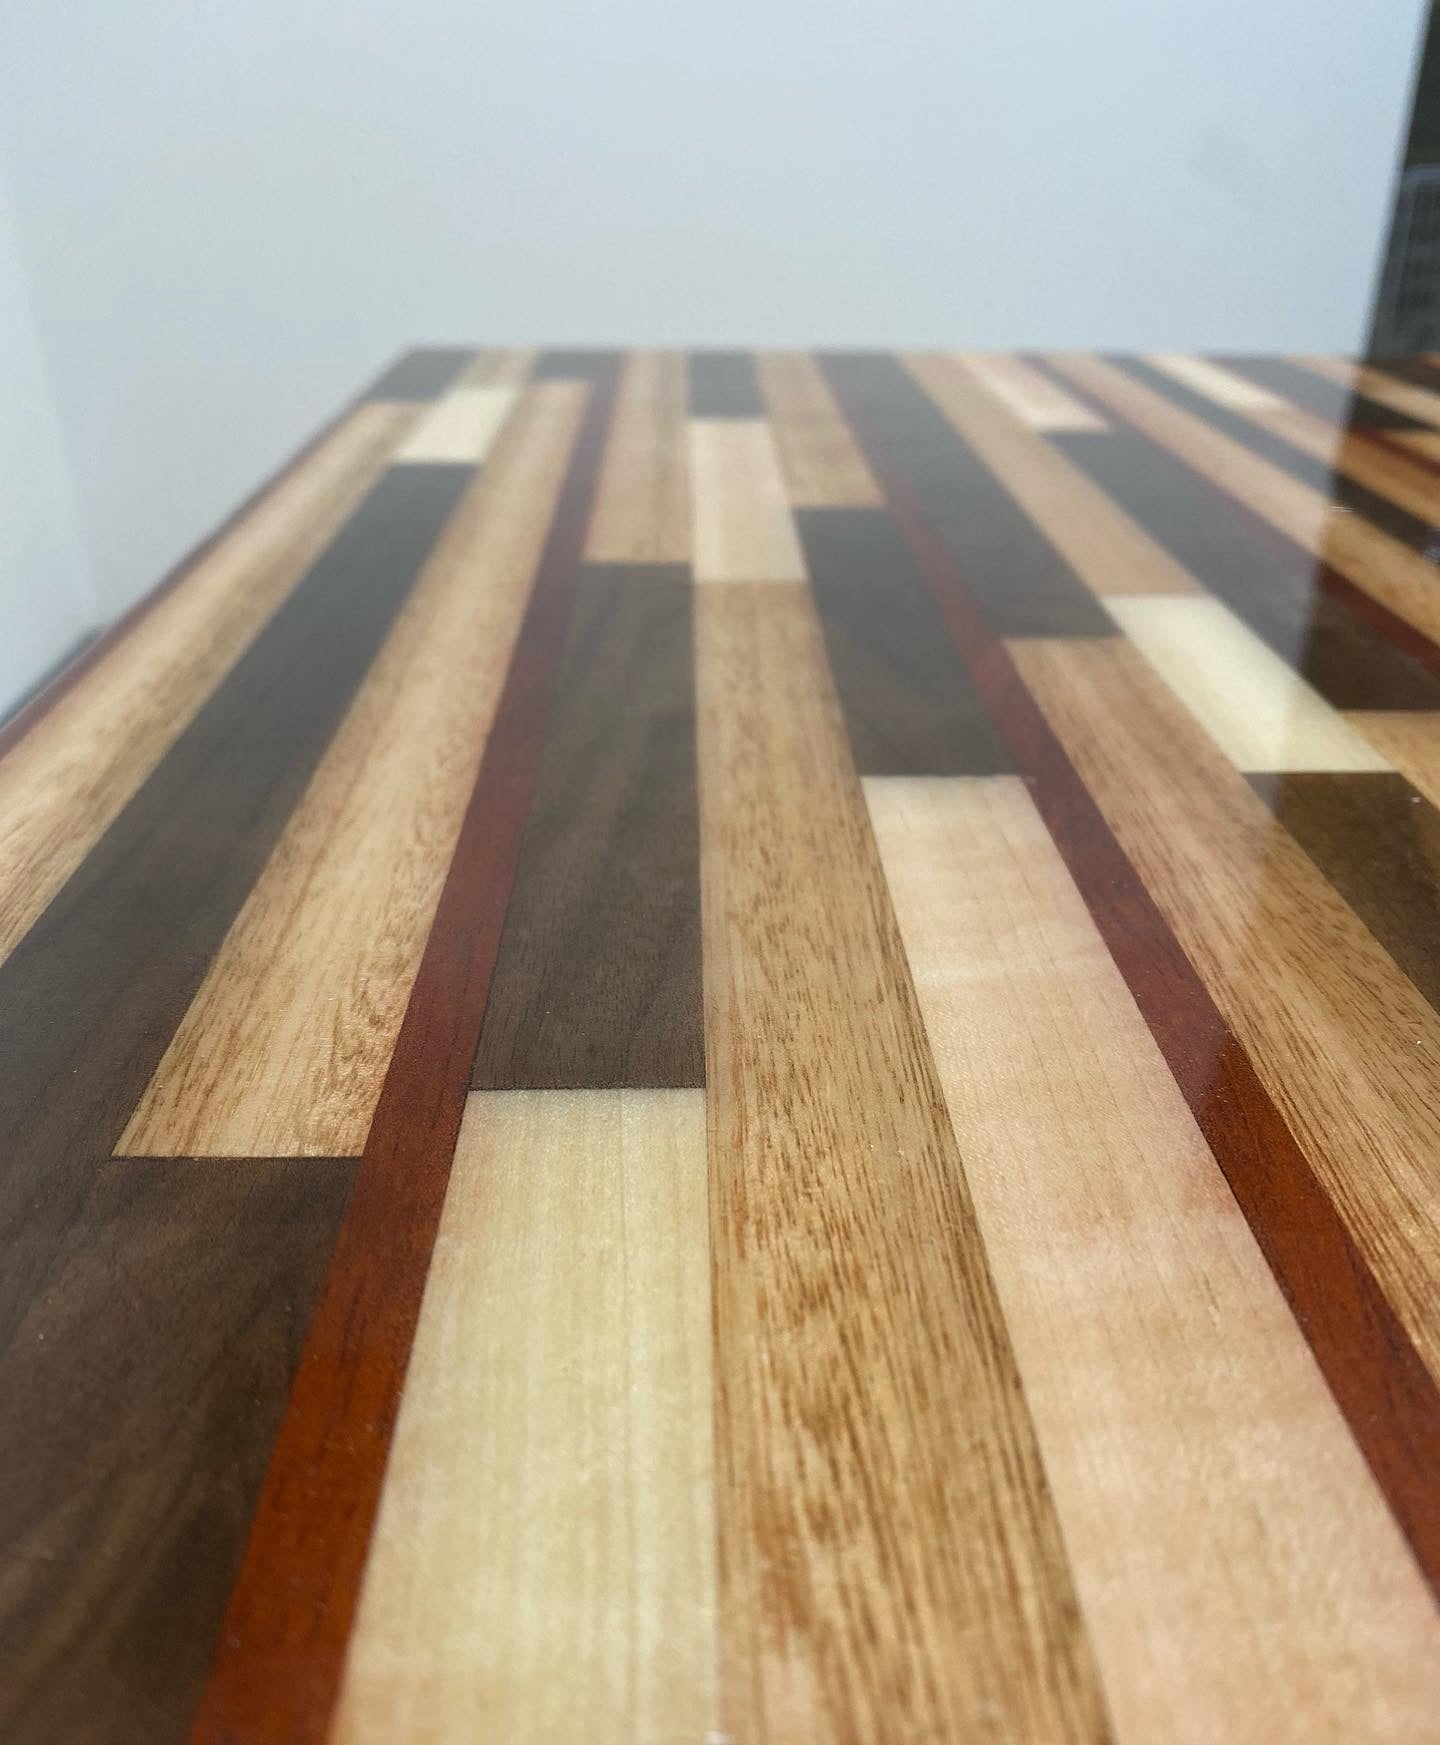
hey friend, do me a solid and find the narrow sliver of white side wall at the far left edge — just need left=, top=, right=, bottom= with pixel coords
left=0, top=158, right=99, bottom=714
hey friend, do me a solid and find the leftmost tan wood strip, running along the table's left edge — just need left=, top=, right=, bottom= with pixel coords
left=0, top=403, right=414, bottom=961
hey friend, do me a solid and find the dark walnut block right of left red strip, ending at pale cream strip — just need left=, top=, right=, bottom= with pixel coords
left=475, top=564, right=705, bottom=1091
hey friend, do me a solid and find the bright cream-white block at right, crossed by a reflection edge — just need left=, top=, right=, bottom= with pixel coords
left=1105, top=595, right=1389, bottom=770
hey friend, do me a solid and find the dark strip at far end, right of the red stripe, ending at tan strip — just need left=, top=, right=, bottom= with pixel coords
left=826, top=352, right=1115, bottom=637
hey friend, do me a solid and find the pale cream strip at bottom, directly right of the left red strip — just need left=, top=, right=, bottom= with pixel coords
left=332, top=1091, right=717, bottom=1745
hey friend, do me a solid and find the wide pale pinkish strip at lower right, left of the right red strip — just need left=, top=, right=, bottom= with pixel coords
left=866, top=777, right=1440, bottom=1745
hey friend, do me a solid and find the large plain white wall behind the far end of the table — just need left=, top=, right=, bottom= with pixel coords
left=0, top=0, right=1421, bottom=628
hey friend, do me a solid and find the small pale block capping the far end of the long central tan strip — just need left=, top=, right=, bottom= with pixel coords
left=689, top=419, right=805, bottom=583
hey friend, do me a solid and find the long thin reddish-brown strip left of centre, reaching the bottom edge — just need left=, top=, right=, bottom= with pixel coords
left=190, top=354, right=614, bottom=1745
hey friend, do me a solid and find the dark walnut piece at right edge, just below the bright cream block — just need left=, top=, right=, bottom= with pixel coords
left=1250, top=771, right=1440, bottom=1012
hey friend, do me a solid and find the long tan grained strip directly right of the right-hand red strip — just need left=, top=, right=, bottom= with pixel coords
left=1011, top=639, right=1440, bottom=1375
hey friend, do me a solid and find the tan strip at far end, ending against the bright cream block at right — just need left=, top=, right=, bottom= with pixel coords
left=906, top=354, right=1199, bottom=599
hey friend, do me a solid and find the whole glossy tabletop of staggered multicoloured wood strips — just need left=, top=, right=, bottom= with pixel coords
left=0, top=349, right=1440, bottom=1745
